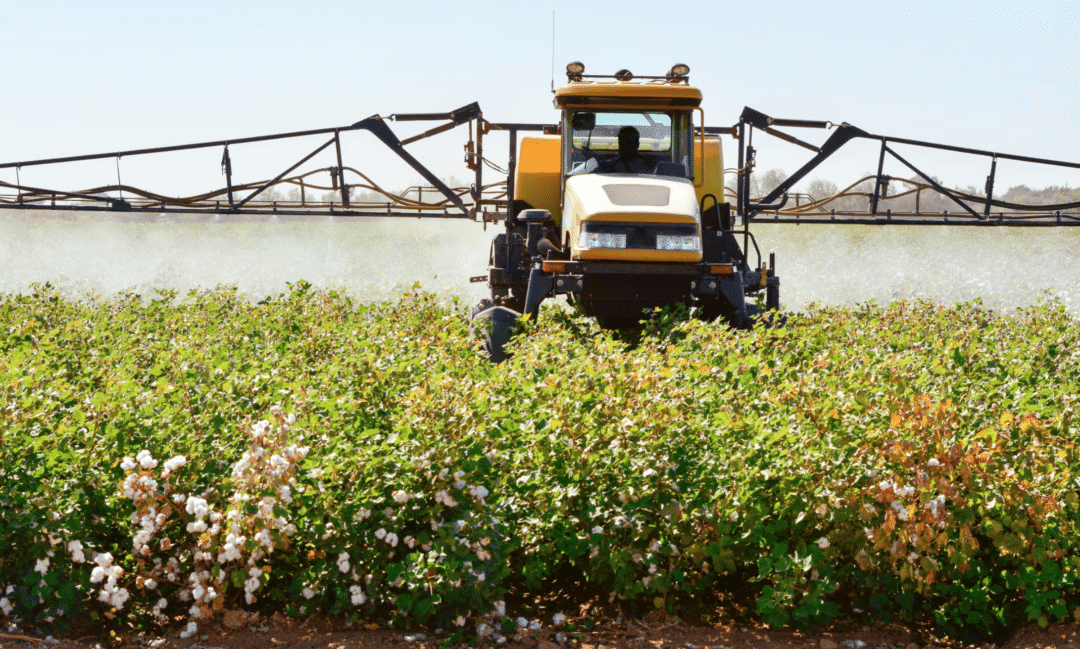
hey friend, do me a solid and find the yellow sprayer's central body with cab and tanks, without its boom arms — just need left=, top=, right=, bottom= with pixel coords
left=485, top=62, right=779, bottom=356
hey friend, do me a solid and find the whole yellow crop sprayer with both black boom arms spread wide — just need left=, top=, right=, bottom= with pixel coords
left=0, top=62, right=1080, bottom=360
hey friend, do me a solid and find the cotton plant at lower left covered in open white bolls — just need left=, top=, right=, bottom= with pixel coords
left=115, top=406, right=309, bottom=637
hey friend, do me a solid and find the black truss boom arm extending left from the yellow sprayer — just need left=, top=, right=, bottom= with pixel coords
left=0, top=103, right=550, bottom=220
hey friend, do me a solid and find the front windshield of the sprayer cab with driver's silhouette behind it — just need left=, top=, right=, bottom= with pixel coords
left=563, top=110, right=693, bottom=178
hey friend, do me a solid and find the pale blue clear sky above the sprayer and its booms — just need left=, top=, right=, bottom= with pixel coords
left=0, top=0, right=1080, bottom=199
